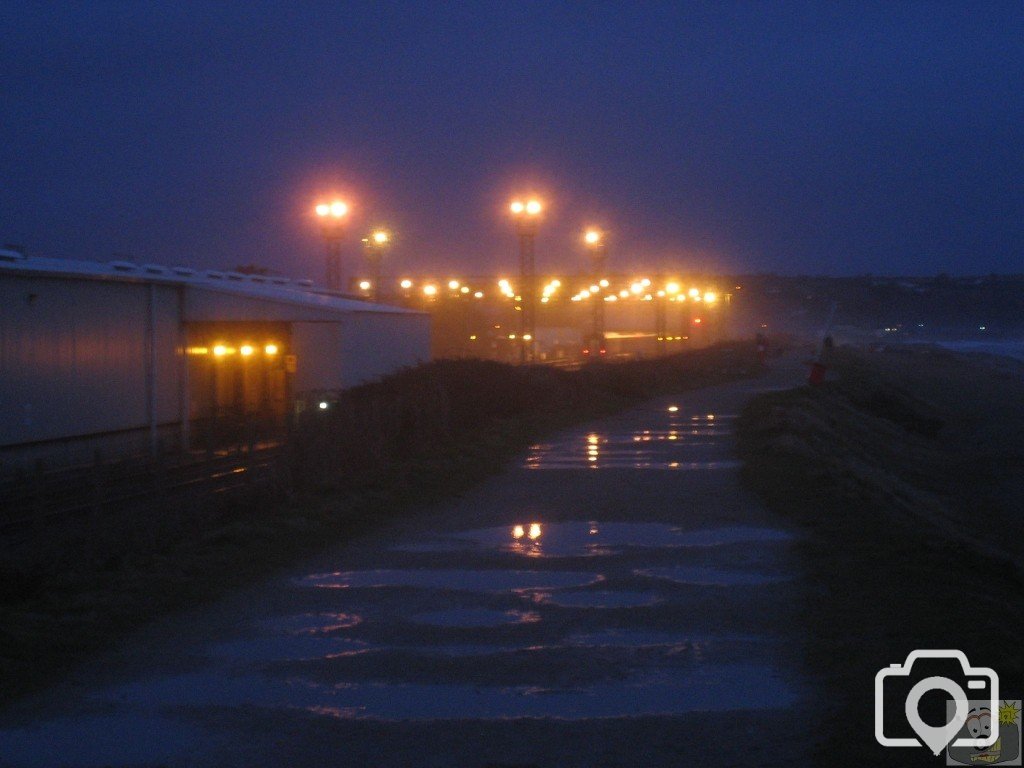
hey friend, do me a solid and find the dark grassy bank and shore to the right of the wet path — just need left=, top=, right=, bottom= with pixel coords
left=739, top=349, right=1024, bottom=766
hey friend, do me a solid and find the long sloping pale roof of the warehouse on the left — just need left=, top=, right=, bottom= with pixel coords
left=0, top=248, right=421, bottom=314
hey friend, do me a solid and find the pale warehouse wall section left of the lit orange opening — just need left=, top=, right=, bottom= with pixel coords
left=0, top=274, right=180, bottom=446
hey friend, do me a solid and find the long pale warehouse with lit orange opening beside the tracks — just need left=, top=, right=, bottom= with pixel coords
left=0, top=250, right=430, bottom=472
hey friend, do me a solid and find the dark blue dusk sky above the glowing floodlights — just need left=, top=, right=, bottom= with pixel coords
left=0, top=0, right=1024, bottom=278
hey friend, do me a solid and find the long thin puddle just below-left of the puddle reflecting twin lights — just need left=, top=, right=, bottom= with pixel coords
left=298, top=569, right=604, bottom=592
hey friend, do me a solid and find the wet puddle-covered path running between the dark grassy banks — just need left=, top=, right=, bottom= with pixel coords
left=0, top=362, right=811, bottom=766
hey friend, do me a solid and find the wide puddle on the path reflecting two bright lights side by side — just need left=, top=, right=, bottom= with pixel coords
left=395, top=521, right=792, bottom=557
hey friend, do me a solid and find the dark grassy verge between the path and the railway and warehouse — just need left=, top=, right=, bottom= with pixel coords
left=0, top=343, right=760, bottom=700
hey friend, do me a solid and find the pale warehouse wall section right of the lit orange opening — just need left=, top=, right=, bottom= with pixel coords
left=292, top=312, right=430, bottom=393
